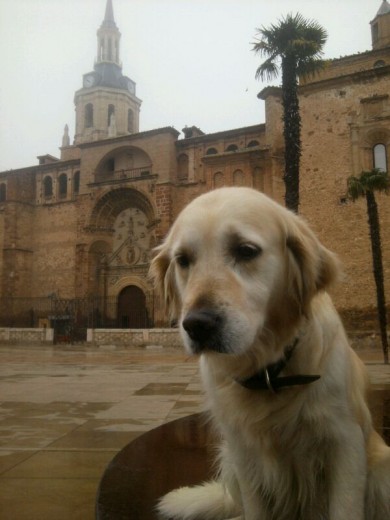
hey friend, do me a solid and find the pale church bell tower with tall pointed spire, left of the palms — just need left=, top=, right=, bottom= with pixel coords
left=74, top=0, right=141, bottom=145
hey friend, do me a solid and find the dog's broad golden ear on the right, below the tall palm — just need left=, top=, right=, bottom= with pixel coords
left=286, top=216, right=340, bottom=313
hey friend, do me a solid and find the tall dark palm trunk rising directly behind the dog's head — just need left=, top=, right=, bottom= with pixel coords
left=282, top=57, right=301, bottom=213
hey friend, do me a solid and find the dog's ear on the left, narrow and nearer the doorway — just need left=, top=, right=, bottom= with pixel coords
left=149, top=244, right=179, bottom=322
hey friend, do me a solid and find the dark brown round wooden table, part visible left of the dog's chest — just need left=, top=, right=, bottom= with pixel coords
left=96, top=414, right=215, bottom=520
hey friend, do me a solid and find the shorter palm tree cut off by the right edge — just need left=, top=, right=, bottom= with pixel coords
left=347, top=168, right=390, bottom=363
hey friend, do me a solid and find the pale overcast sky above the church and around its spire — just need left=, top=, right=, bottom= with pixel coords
left=0, top=0, right=381, bottom=171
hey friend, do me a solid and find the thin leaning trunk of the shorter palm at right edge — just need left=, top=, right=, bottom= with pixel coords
left=366, top=190, right=389, bottom=363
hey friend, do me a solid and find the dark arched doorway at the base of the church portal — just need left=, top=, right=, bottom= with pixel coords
left=118, top=285, right=149, bottom=329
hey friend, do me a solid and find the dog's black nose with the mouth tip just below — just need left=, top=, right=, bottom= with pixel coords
left=182, top=309, right=224, bottom=353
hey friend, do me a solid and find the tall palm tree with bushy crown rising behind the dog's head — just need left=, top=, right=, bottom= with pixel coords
left=253, top=13, right=328, bottom=213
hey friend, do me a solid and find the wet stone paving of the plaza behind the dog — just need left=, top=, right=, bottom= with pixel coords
left=0, top=345, right=390, bottom=520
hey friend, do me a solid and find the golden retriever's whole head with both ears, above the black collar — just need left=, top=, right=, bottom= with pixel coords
left=151, top=188, right=337, bottom=360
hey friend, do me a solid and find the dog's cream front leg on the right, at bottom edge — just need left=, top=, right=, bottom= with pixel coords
left=329, top=425, right=367, bottom=520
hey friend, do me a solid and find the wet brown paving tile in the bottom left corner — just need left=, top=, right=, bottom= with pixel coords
left=0, top=478, right=97, bottom=520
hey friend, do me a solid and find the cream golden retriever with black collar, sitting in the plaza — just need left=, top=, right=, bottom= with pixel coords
left=151, top=188, right=390, bottom=520
